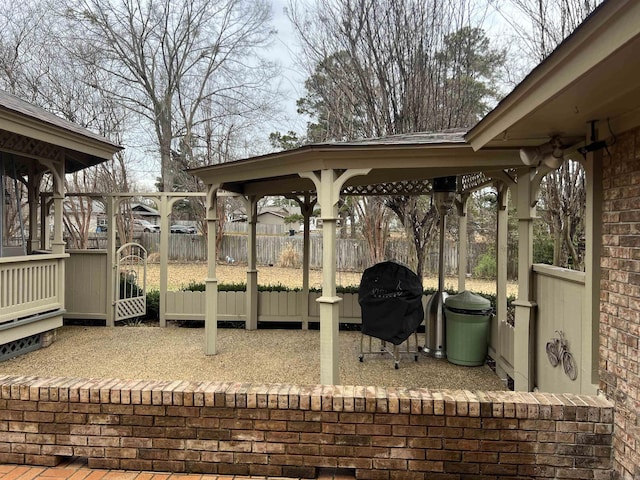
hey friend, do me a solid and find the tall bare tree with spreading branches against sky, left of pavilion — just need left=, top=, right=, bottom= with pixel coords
left=65, top=0, right=280, bottom=191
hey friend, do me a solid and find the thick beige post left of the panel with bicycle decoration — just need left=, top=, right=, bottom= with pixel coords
left=513, top=168, right=537, bottom=392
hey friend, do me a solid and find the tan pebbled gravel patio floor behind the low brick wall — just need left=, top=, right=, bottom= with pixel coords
left=0, top=324, right=505, bottom=390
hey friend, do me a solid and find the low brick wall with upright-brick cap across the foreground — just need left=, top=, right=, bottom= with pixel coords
left=0, top=376, right=613, bottom=480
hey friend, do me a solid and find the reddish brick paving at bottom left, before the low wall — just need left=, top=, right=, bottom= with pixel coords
left=0, top=458, right=355, bottom=480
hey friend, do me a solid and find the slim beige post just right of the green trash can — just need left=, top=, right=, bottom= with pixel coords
left=491, top=182, right=513, bottom=379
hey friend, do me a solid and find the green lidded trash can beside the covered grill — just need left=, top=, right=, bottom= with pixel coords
left=444, top=291, right=493, bottom=367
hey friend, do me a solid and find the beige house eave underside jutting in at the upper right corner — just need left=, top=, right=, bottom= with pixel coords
left=465, top=0, right=640, bottom=149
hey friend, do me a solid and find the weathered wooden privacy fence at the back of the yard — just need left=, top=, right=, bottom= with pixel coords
left=141, top=233, right=458, bottom=274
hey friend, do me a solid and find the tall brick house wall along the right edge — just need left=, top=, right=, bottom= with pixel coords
left=600, top=129, right=640, bottom=480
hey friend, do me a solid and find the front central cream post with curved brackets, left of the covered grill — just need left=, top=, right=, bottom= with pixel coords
left=300, top=169, right=371, bottom=385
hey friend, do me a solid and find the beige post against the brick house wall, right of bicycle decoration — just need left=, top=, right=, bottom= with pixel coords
left=578, top=150, right=603, bottom=395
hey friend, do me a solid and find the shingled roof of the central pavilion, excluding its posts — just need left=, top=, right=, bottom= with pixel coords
left=191, top=130, right=523, bottom=196
